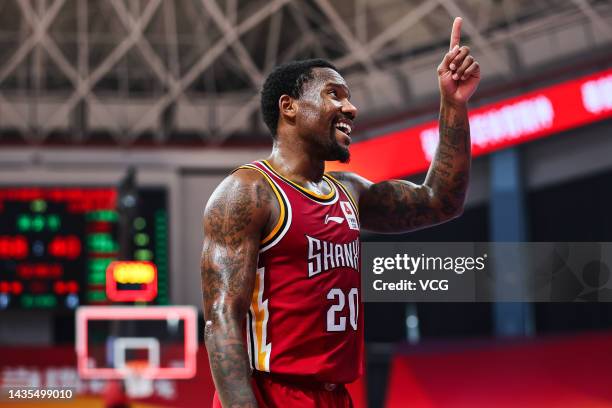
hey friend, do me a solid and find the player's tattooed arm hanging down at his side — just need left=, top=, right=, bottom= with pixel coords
left=201, top=170, right=270, bottom=408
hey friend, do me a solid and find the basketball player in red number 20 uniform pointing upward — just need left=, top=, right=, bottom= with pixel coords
left=201, top=18, right=480, bottom=408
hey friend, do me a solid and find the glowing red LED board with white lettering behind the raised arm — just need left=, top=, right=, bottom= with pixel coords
left=326, top=69, right=612, bottom=181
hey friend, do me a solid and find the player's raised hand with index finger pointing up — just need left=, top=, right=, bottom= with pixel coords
left=438, top=17, right=480, bottom=104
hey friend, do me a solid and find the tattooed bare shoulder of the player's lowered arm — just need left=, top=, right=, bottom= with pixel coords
left=204, top=169, right=273, bottom=239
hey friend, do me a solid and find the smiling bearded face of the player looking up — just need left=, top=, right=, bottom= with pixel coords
left=295, top=68, right=357, bottom=163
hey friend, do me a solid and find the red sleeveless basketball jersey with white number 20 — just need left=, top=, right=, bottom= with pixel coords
left=240, top=160, right=364, bottom=383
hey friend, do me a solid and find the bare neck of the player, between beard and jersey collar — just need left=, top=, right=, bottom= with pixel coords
left=268, top=138, right=325, bottom=183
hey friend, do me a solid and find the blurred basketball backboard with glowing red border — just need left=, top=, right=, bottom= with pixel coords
left=76, top=306, right=198, bottom=379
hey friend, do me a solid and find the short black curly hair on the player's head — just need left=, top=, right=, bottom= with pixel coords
left=261, top=58, right=338, bottom=139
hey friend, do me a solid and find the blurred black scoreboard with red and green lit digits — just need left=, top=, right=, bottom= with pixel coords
left=0, top=187, right=169, bottom=310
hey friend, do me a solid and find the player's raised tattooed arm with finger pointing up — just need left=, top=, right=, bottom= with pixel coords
left=335, top=17, right=480, bottom=233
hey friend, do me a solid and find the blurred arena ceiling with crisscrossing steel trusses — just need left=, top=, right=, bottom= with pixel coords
left=0, top=0, right=612, bottom=146
